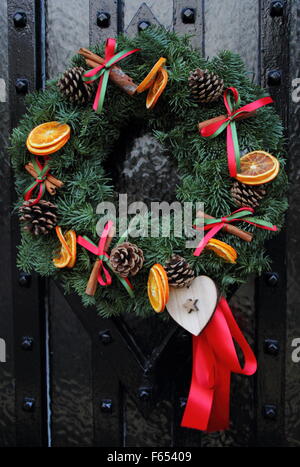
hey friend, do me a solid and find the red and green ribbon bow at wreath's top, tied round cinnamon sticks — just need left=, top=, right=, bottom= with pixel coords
left=82, top=38, right=140, bottom=113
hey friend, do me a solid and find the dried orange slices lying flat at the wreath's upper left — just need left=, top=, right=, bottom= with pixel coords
left=27, top=122, right=71, bottom=149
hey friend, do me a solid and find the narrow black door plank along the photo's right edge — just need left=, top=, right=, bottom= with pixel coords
left=285, top=0, right=300, bottom=446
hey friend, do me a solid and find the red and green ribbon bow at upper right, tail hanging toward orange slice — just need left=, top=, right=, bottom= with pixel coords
left=200, top=87, right=274, bottom=177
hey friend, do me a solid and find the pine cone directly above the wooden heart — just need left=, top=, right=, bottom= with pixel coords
left=165, top=255, right=195, bottom=288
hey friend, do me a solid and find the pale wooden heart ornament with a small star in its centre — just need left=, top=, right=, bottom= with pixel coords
left=167, top=276, right=218, bottom=336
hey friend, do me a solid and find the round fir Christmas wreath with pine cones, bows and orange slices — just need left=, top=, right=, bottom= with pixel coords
left=11, top=28, right=287, bottom=317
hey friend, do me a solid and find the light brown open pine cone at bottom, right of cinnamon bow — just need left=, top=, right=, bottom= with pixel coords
left=109, top=242, right=144, bottom=277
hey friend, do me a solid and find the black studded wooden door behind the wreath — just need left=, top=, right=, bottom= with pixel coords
left=0, top=0, right=300, bottom=447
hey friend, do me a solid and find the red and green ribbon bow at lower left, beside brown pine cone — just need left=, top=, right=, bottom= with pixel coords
left=77, top=221, right=134, bottom=298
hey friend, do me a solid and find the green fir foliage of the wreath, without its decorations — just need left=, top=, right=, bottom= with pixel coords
left=10, top=27, right=287, bottom=317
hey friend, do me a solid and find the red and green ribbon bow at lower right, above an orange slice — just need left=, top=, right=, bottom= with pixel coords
left=194, top=207, right=277, bottom=256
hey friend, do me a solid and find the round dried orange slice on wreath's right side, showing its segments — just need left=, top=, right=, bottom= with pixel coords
left=236, top=151, right=280, bottom=185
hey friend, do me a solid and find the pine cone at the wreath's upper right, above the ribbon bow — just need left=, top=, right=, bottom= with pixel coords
left=189, top=68, right=224, bottom=104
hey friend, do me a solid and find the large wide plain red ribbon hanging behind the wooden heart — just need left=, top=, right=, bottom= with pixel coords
left=181, top=297, right=257, bottom=432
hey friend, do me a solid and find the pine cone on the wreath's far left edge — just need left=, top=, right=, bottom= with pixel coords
left=19, top=199, right=57, bottom=235
